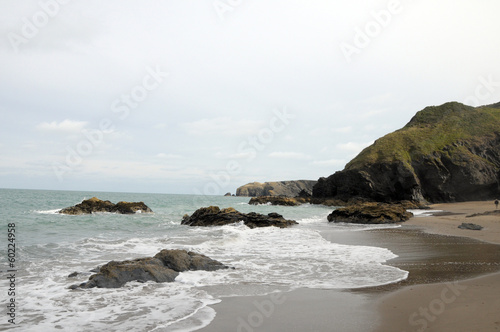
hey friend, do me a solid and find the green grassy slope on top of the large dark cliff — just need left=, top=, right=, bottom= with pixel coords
left=345, top=102, right=500, bottom=169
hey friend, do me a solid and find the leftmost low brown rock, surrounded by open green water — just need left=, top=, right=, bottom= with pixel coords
left=59, top=197, right=153, bottom=215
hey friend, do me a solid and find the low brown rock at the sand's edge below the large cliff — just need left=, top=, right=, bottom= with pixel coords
left=327, top=202, right=413, bottom=224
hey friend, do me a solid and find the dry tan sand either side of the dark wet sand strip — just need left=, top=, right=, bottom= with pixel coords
left=376, top=201, right=500, bottom=332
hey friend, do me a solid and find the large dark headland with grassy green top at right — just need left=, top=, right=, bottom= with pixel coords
left=313, top=102, right=500, bottom=203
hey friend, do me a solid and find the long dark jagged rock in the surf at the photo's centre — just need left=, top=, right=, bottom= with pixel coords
left=181, top=206, right=297, bottom=228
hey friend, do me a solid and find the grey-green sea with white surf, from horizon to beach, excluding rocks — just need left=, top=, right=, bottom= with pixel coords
left=0, top=189, right=408, bottom=331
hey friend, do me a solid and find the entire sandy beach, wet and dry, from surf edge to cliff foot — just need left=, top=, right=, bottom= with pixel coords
left=199, top=201, right=500, bottom=332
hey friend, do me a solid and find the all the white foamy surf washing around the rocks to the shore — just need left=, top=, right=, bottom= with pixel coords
left=12, top=198, right=407, bottom=332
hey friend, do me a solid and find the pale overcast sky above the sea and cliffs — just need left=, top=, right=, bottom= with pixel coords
left=0, top=0, right=500, bottom=195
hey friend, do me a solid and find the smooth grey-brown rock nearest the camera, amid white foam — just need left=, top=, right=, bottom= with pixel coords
left=70, top=249, right=228, bottom=289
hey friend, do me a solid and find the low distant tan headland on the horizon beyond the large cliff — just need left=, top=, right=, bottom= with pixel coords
left=236, top=180, right=317, bottom=197
